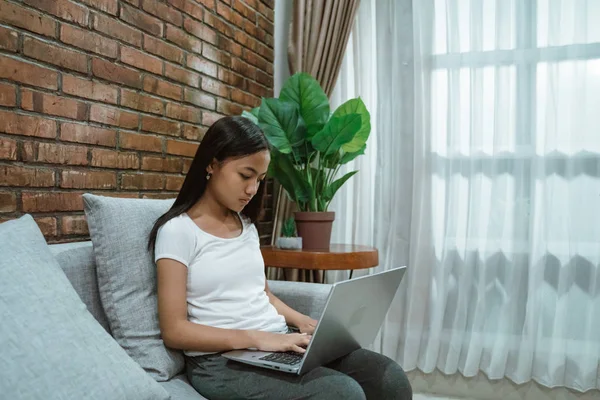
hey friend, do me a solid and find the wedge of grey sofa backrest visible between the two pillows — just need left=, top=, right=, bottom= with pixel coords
left=48, top=242, right=110, bottom=333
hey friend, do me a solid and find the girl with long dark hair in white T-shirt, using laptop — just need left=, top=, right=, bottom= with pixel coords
left=148, top=117, right=412, bottom=400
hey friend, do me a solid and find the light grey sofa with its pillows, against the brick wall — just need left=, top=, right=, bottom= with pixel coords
left=0, top=197, right=331, bottom=400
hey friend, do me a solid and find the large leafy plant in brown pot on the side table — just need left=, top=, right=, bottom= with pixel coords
left=242, top=73, right=371, bottom=250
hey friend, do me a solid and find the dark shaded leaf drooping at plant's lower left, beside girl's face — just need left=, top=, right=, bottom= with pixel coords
left=269, top=150, right=314, bottom=203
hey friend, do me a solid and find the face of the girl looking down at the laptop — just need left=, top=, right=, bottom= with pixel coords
left=207, top=150, right=271, bottom=212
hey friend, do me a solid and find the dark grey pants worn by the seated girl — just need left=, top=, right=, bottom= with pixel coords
left=186, top=349, right=412, bottom=400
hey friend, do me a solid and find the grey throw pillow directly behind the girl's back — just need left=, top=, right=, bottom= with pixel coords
left=83, top=194, right=184, bottom=381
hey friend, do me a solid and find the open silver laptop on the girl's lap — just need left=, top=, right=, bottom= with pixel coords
left=223, top=267, right=406, bottom=375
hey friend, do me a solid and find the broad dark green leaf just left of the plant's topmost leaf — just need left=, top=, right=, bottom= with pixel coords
left=258, top=98, right=306, bottom=154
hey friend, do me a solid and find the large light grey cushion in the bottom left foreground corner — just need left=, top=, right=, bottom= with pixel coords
left=0, top=215, right=169, bottom=400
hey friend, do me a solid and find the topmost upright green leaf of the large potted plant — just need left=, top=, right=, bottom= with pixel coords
left=279, top=73, right=329, bottom=139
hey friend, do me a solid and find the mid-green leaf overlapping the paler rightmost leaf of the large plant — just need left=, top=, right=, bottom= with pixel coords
left=312, top=114, right=361, bottom=156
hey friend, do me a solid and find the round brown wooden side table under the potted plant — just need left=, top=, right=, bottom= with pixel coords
left=261, top=244, right=379, bottom=283
